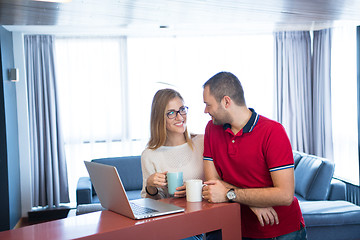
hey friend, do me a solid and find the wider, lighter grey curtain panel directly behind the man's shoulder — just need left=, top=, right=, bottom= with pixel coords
left=274, top=31, right=313, bottom=153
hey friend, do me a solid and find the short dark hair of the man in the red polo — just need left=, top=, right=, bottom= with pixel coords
left=203, top=72, right=246, bottom=106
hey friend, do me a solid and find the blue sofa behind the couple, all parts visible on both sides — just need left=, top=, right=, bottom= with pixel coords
left=76, top=151, right=360, bottom=240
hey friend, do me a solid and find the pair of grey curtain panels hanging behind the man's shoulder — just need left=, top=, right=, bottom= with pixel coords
left=274, top=29, right=333, bottom=159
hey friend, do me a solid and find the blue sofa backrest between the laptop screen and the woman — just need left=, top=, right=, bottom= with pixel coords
left=92, top=156, right=142, bottom=191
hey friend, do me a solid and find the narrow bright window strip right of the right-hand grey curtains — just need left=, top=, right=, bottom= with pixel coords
left=331, top=27, right=359, bottom=185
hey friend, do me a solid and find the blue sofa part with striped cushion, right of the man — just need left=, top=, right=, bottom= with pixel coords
left=293, top=151, right=360, bottom=240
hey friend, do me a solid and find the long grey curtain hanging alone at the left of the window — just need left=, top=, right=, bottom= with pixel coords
left=25, top=35, right=69, bottom=207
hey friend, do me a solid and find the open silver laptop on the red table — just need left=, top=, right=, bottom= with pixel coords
left=84, top=161, right=185, bottom=219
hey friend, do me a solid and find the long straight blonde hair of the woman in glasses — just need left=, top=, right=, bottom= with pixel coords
left=148, top=88, right=192, bottom=149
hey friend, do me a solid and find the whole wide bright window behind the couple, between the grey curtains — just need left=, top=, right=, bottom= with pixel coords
left=55, top=34, right=273, bottom=203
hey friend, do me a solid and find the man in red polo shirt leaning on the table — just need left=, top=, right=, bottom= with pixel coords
left=203, top=72, right=306, bottom=240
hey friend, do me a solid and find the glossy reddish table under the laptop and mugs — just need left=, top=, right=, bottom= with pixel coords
left=0, top=198, right=241, bottom=240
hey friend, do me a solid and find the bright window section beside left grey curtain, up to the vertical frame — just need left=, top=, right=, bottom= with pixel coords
left=55, top=37, right=132, bottom=202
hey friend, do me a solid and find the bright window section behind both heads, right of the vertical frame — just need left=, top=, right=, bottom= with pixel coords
left=128, top=34, right=273, bottom=138
